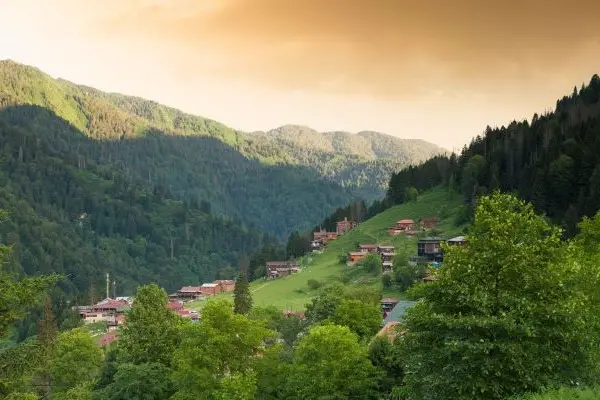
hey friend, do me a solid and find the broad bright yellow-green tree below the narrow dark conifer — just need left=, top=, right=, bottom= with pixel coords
left=172, top=300, right=273, bottom=399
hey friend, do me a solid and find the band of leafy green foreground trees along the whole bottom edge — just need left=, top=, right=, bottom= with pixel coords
left=0, top=193, right=600, bottom=400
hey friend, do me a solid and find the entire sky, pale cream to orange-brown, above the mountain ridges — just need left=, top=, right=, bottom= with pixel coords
left=0, top=0, right=600, bottom=149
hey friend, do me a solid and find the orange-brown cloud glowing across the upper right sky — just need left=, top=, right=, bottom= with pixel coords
left=81, top=0, right=600, bottom=98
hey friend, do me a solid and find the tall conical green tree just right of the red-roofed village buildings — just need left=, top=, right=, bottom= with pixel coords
left=119, top=283, right=180, bottom=366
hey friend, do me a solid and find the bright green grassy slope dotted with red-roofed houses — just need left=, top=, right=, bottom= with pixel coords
left=189, top=189, right=463, bottom=310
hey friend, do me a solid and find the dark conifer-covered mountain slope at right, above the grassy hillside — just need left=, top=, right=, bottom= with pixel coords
left=388, top=75, right=600, bottom=235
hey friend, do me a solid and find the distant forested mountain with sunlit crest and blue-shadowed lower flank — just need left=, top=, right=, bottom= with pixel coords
left=0, top=61, right=443, bottom=238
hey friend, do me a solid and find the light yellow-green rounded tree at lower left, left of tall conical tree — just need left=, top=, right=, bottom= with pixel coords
left=49, top=328, right=103, bottom=396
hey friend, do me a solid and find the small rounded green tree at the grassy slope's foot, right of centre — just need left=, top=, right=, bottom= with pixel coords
left=332, top=300, right=381, bottom=341
